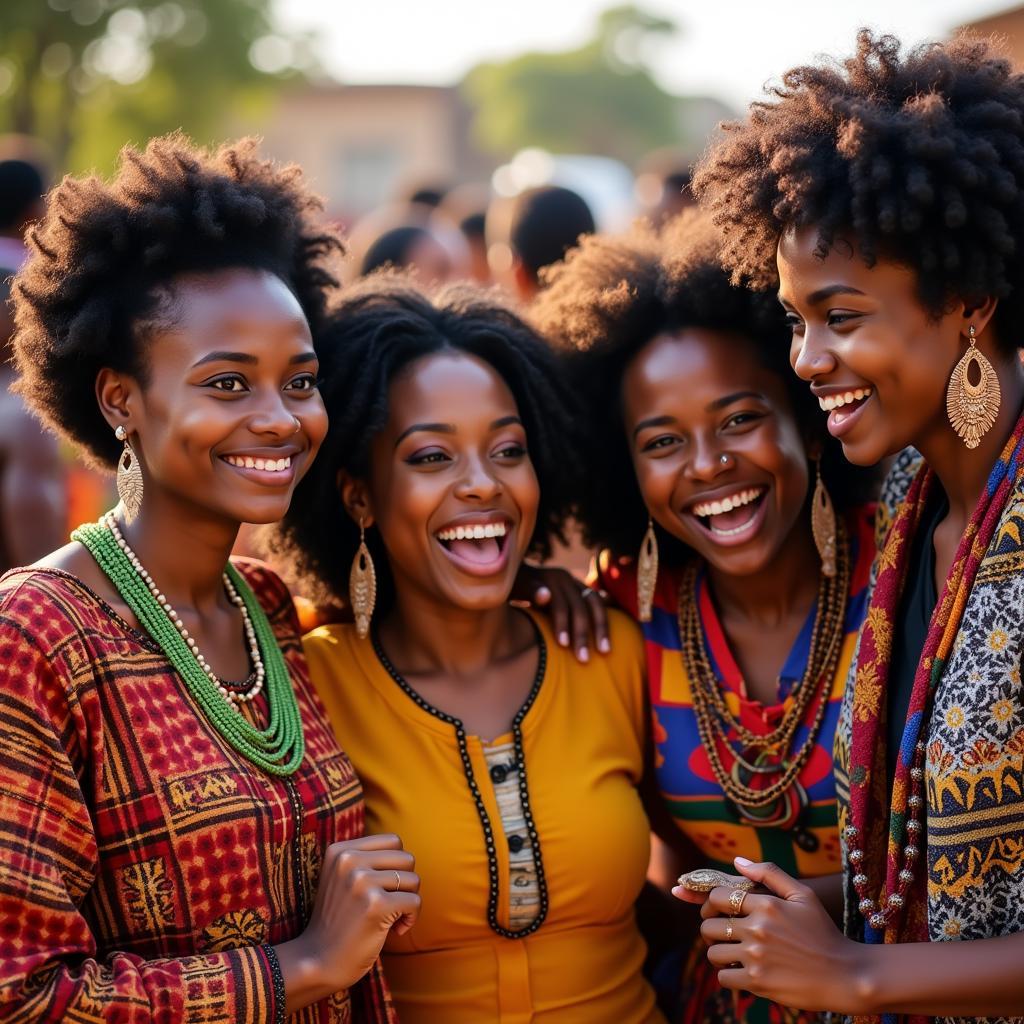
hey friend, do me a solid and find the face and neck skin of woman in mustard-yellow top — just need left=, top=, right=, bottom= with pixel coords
left=341, top=353, right=540, bottom=739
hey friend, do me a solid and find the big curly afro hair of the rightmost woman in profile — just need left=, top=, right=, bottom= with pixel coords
left=693, top=29, right=1024, bottom=351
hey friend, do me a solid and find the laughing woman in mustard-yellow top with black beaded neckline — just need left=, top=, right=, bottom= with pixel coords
left=279, top=278, right=662, bottom=1024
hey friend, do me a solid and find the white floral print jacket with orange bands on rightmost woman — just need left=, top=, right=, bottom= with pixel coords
left=836, top=451, right=1024, bottom=1024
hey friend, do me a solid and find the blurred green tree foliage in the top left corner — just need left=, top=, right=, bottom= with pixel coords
left=0, top=0, right=314, bottom=172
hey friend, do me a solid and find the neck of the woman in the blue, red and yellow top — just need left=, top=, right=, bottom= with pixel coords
left=708, top=518, right=821, bottom=629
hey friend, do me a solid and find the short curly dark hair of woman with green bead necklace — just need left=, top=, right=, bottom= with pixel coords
left=13, top=133, right=342, bottom=468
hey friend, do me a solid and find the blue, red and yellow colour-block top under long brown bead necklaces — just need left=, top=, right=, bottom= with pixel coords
left=598, top=506, right=874, bottom=1024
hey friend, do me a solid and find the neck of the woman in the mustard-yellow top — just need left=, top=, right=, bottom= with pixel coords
left=380, top=587, right=528, bottom=680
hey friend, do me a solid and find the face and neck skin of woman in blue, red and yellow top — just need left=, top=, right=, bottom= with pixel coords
left=622, top=328, right=841, bottom=913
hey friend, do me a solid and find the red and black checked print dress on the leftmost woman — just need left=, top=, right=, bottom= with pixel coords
left=0, top=560, right=396, bottom=1024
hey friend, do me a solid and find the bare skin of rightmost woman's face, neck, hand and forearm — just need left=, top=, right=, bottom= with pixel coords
left=684, top=229, right=1024, bottom=1017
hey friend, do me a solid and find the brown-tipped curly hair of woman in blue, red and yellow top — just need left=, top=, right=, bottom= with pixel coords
left=532, top=211, right=877, bottom=564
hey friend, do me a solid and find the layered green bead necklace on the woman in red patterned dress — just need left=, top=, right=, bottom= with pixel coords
left=72, top=512, right=305, bottom=776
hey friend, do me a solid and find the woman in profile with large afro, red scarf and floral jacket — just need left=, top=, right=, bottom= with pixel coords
left=684, top=31, right=1024, bottom=1020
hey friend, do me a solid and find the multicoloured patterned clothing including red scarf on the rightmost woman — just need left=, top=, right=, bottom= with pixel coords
left=836, top=440, right=1024, bottom=1024
